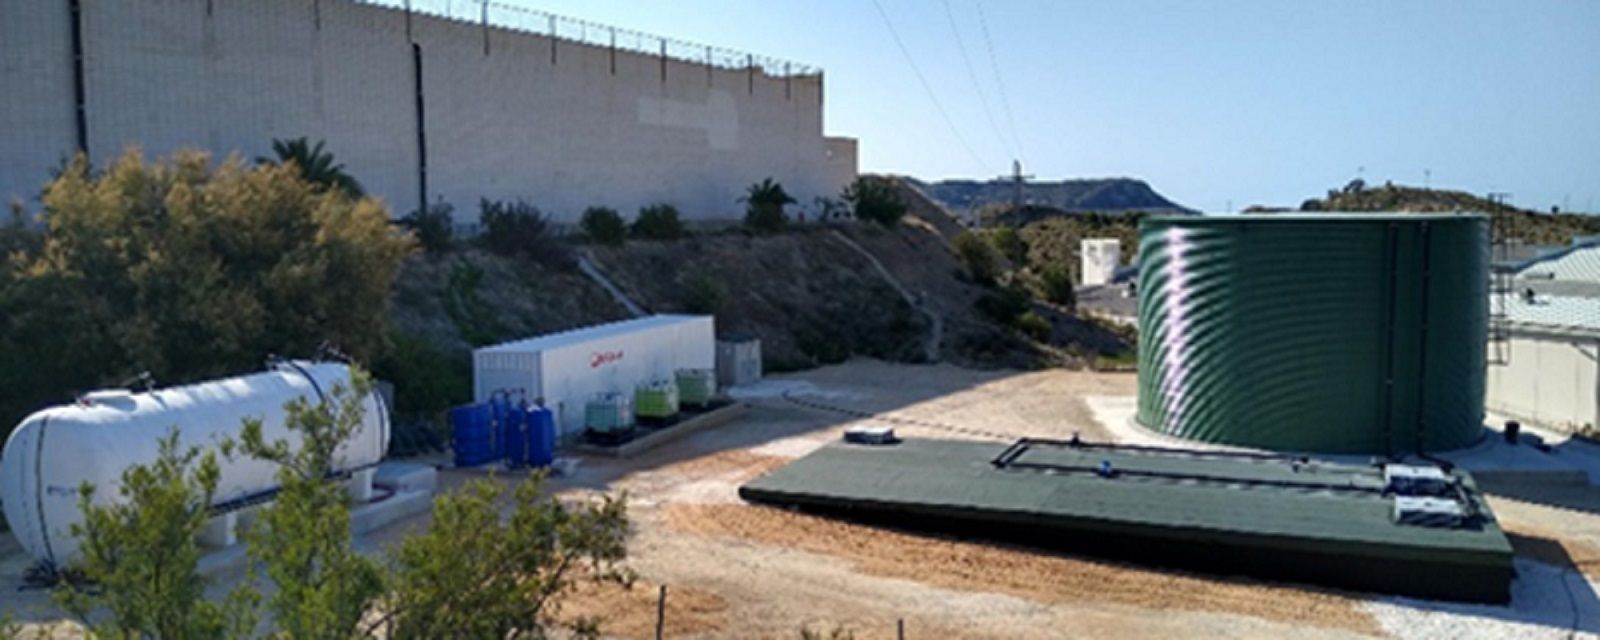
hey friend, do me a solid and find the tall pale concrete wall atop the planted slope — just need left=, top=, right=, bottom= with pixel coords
left=0, top=0, right=854, bottom=221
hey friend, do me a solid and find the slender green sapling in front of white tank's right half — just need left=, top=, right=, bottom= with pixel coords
left=238, top=371, right=384, bottom=638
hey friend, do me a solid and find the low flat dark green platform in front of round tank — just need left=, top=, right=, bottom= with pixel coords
left=739, top=440, right=1512, bottom=602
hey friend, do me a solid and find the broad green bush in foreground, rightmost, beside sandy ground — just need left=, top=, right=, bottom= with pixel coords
left=386, top=475, right=632, bottom=638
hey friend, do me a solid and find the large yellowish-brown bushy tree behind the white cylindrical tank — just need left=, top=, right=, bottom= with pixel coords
left=0, top=152, right=414, bottom=448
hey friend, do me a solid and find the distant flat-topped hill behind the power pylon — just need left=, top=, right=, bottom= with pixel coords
left=912, top=178, right=1194, bottom=219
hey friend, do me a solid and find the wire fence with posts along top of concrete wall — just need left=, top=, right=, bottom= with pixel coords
left=349, top=0, right=822, bottom=78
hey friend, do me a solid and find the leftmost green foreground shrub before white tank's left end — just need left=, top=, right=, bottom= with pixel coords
left=54, top=429, right=256, bottom=638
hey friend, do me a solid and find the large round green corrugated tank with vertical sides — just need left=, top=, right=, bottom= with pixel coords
left=1138, top=213, right=1488, bottom=454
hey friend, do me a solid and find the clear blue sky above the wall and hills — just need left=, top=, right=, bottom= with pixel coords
left=518, top=0, right=1600, bottom=211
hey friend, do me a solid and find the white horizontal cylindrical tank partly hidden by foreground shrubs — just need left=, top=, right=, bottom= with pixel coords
left=0, top=362, right=389, bottom=566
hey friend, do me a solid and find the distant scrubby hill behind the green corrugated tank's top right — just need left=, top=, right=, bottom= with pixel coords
left=1286, top=181, right=1600, bottom=245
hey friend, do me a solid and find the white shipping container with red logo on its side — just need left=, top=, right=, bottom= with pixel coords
left=472, top=315, right=717, bottom=437
